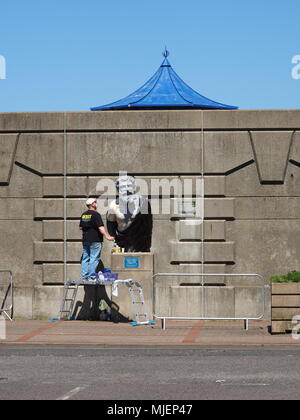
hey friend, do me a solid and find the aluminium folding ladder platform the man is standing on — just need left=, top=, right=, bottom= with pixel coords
left=58, top=279, right=154, bottom=326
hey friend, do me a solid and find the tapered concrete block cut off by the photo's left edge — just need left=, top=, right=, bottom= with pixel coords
left=0, top=134, right=18, bottom=184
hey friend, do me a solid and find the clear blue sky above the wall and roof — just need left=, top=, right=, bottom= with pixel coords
left=0, top=0, right=300, bottom=112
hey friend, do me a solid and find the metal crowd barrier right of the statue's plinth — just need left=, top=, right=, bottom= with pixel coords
left=153, top=273, right=268, bottom=330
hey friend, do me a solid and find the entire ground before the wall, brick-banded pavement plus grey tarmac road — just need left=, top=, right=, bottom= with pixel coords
left=0, top=319, right=300, bottom=400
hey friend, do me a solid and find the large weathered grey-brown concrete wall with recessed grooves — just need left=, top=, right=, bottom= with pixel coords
left=0, top=110, right=300, bottom=318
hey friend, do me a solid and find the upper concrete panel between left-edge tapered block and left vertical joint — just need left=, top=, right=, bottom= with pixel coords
left=16, top=133, right=64, bottom=175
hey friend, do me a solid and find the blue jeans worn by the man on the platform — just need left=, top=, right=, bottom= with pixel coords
left=81, top=242, right=103, bottom=280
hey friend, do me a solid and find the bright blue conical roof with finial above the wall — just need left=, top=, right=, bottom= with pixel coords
left=91, top=51, right=237, bottom=111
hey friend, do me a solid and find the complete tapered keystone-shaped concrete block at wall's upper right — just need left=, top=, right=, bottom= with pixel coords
left=251, top=131, right=293, bottom=182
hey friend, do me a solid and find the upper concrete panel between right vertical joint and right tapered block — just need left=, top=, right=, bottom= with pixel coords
left=204, top=131, right=254, bottom=174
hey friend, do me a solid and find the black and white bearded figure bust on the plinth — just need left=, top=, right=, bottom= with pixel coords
left=107, top=175, right=153, bottom=252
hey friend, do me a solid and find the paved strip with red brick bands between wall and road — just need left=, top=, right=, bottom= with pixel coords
left=0, top=320, right=300, bottom=348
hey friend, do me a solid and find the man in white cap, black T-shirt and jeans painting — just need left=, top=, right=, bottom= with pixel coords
left=79, top=198, right=114, bottom=280
